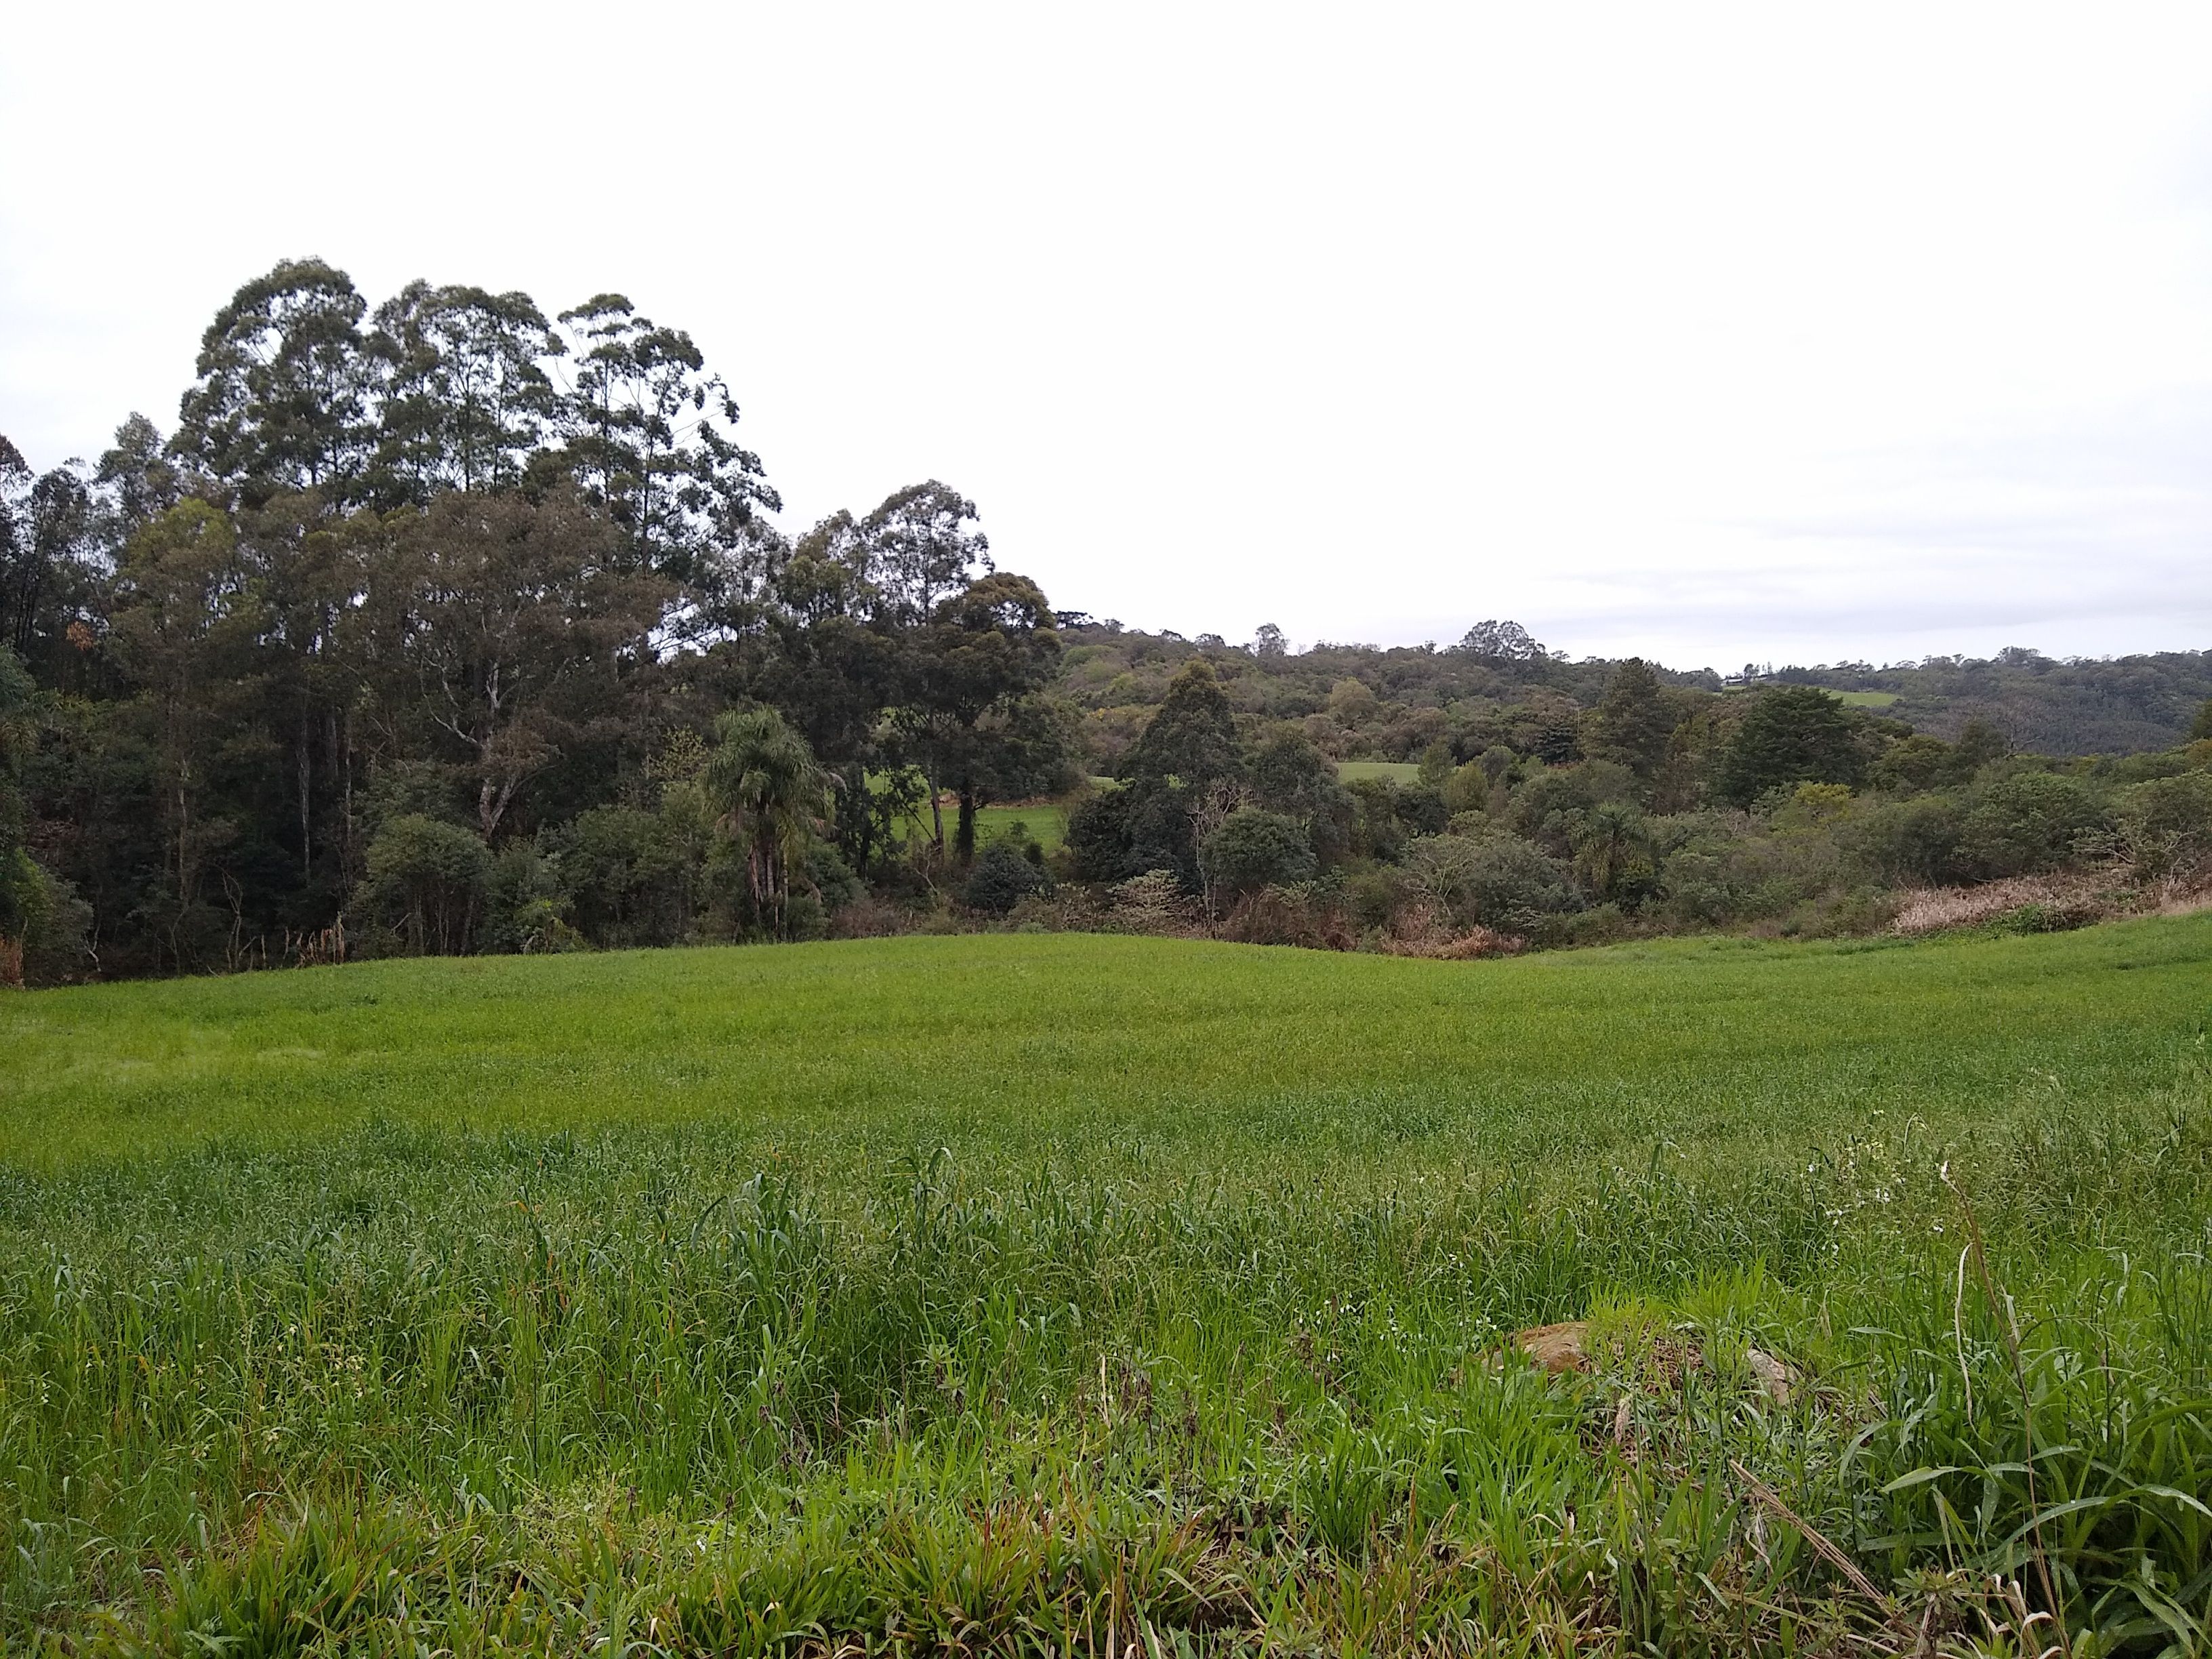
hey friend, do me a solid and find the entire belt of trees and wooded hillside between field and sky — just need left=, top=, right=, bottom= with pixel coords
left=0, top=261, right=2212, bottom=982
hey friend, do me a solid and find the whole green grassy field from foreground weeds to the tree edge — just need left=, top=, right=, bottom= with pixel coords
left=0, top=918, right=2212, bottom=1654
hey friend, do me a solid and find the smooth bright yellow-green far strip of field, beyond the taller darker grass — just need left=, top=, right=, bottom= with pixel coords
left=0, top=918, right=2212, bottom=1164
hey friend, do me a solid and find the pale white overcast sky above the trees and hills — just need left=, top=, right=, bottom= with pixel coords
left=0, top=0, right=2212, bottom=668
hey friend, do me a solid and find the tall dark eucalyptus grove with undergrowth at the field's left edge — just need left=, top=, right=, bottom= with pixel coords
left=0, top=261, right=1073, bottom=975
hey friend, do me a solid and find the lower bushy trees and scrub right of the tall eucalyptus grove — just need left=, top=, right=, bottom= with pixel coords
left=1044, top=650, right=2212, bottom=956
